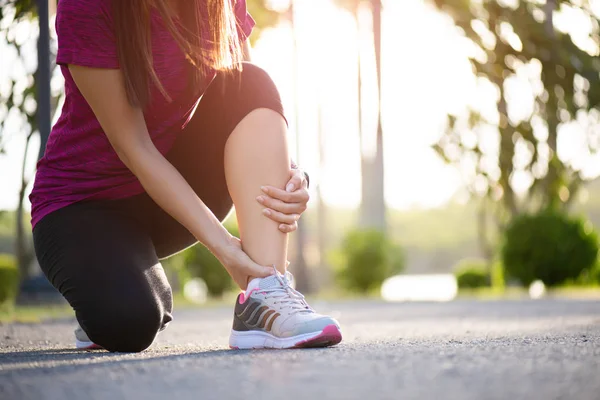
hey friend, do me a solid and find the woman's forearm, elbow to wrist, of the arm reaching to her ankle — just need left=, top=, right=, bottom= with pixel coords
left=122, top=144, right=231, bottom=254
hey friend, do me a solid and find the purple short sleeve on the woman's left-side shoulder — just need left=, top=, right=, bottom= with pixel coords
left=56, top=0, right=119, bottom=68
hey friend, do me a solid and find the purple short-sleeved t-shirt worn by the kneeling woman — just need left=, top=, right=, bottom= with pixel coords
left=29, top=0, right=255, bottom=226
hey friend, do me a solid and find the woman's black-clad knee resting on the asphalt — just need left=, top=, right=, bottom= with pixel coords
left=81, top=299, right=170, bottom=353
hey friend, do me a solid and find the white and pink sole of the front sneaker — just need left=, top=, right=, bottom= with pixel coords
left=229, top=325, right=342, bottom=350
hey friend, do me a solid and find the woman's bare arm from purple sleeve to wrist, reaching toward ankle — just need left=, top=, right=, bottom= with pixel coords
left=69, top=65, right=231, bottom=253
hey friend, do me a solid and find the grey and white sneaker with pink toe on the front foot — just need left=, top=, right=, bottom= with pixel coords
left=229, top=272, right=342, bottom=349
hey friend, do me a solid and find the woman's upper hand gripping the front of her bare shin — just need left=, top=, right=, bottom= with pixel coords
left=256, top=169, right=310, bottom=233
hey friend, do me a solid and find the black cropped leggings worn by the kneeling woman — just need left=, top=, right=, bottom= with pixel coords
left=33, top=63, right=283, bottom=352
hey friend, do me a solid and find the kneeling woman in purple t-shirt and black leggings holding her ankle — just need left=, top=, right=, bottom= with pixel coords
left=31, top=0, right=341, bottom=352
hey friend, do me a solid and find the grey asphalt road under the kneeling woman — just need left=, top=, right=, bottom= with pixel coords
left=0, top=300, right=600, bottom=400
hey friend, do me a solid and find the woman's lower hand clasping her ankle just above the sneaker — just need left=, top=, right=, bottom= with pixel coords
left=214, top=236, right=275, bottom=290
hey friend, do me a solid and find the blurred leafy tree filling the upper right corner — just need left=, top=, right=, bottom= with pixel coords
left=435, top=0, right=600, bottom=255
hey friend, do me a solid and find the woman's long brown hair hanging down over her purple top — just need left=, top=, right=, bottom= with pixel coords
left=111, top=0, right=242, bottom=107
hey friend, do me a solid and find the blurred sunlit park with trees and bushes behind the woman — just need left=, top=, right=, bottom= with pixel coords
left=0, top=0, right=600, bottom=315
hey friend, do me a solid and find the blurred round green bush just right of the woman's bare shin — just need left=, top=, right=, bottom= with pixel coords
left=336, top=230, right=405, bottom=293
